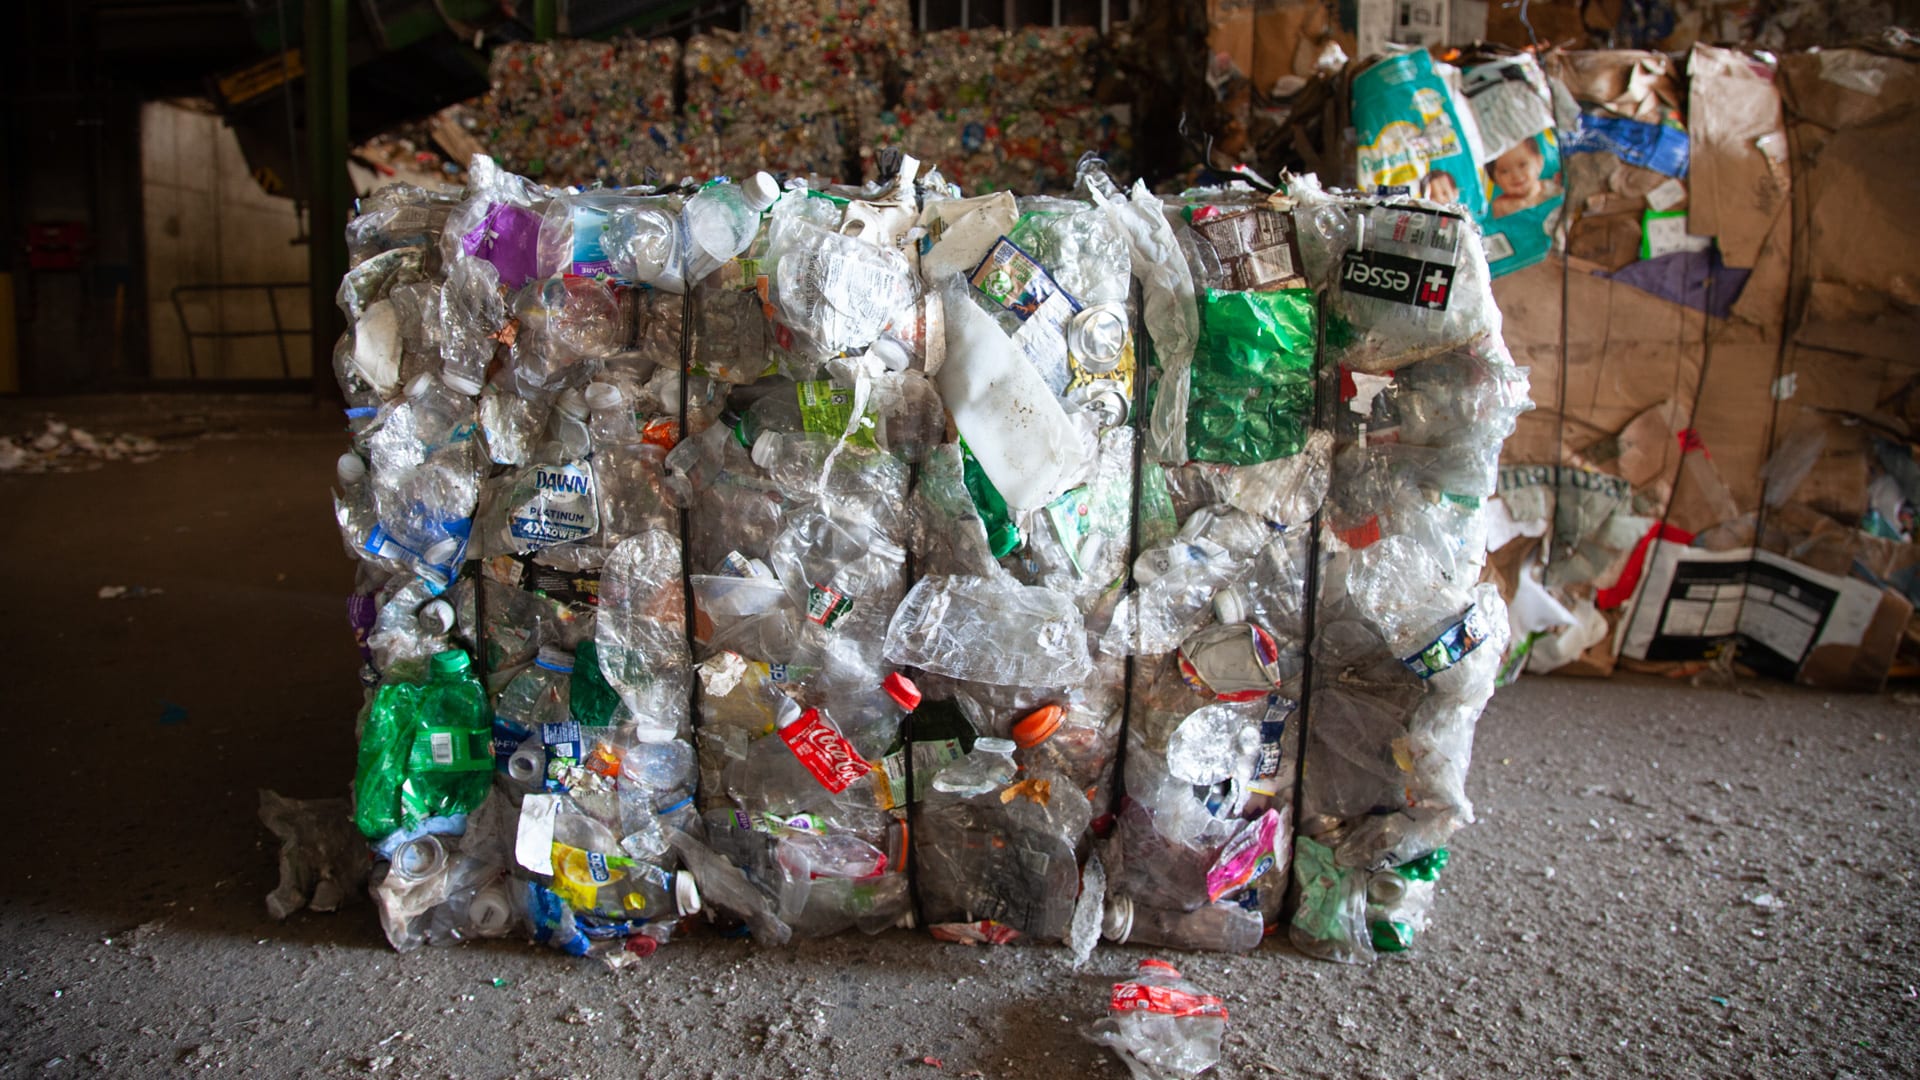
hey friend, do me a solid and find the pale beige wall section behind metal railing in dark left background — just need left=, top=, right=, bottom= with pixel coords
left=140, top=102, right=311, bottom=379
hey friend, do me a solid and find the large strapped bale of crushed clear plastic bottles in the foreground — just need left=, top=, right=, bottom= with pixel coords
left=311, top=147, right=1526, bottom=960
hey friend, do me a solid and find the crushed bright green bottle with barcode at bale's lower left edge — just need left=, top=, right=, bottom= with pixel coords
left=353, top=650, right=493, bottom=840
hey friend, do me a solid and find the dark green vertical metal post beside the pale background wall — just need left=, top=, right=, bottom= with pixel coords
left=303, top=0, right=353, bottom=400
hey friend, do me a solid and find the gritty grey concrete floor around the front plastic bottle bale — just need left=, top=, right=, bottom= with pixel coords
left=0, top=398, right=1920, bottom=1078
